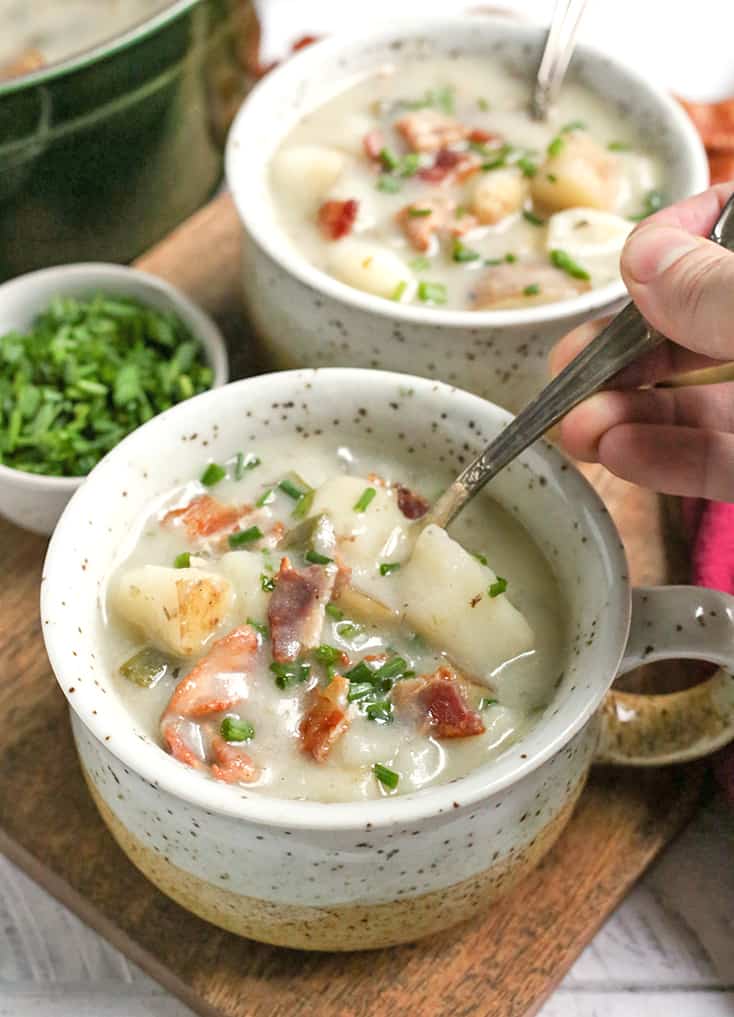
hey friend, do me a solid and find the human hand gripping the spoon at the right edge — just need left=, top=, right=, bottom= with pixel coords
left=551, top=183, right=734, bottom=501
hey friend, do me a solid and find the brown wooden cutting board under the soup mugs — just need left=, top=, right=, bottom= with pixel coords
left=0, top=196, right=704, bottom=1017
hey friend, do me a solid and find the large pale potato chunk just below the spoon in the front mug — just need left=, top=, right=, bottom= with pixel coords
left=397, top=525, right=535, bottom=681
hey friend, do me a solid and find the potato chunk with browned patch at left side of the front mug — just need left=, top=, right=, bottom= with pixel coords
left=112, top=565, right=233, bottom=657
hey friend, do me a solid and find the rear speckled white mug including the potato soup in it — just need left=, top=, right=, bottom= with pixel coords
left=227, top=16, right=709, bottom=410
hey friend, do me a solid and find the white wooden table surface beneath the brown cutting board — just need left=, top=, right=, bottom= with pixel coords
left=0, top=0, right=734, bottom=1017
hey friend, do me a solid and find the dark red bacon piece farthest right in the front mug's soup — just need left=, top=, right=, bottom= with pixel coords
left=392, top=667, right=484, bottom=738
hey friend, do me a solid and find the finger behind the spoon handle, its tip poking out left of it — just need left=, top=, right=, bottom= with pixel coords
left=550, top=321, right=721, bottom=388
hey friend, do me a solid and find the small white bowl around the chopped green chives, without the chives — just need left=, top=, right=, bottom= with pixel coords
left=0, top=262, right=229, bottom=535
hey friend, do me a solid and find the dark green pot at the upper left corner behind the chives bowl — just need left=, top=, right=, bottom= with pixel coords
left=0, top=0, right=256, bottom=281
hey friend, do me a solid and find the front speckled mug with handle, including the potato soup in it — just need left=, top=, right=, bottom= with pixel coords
left=42, top=368, right=734, bottom=950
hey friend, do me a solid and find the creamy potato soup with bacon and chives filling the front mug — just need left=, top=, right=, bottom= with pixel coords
left=106, top=439, right=565, bottom=801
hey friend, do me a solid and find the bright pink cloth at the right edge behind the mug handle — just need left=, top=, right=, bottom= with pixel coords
left=683, top=498, right=734, bottom=805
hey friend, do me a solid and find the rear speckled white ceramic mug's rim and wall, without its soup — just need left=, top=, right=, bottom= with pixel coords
left=226, top=15, right=709, bottom=412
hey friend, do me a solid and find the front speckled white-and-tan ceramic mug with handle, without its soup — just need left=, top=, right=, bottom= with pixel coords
left=42, top=369, right=734, bottom=950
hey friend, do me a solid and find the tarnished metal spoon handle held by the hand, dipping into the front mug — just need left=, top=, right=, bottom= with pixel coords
left=427, top=194, right=734, bottom=527
